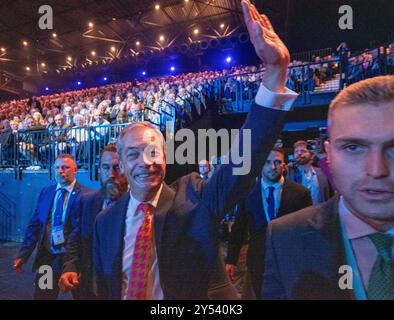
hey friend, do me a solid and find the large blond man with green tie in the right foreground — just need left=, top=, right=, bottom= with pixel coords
left=262, top=76, right=394, bottom=300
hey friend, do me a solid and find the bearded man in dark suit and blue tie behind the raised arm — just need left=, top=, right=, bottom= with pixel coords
left=226, top=148, right=312, bottom=299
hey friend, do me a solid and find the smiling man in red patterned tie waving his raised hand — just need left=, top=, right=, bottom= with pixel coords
left=93, top=1, right=296, bottom=299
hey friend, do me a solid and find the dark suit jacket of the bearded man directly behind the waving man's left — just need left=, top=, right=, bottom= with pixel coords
left=63, top=190, right=104, bottom=298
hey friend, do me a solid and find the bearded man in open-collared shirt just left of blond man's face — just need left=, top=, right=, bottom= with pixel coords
left=288, top=140, right=334, bottom=205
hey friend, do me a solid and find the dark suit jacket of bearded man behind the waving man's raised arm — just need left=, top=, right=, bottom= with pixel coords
left=226, top=177, right=312, bottom=297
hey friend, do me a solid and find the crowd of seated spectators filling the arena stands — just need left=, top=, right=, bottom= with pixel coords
left=0, top=44, right=394, bottom=169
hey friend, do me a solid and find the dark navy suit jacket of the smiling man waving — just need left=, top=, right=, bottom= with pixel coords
left=93, top=105, right=285, bottom=300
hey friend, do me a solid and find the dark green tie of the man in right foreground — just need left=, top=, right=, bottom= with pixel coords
left=368, top=233, right=394, bottom=300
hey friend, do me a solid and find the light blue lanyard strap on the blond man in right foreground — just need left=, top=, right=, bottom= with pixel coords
left=339, top=214, right=368, bottom=300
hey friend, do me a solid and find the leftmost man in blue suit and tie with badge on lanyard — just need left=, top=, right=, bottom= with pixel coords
left=13, top=154, right=89, bottom=300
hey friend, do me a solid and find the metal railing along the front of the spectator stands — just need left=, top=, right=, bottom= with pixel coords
left=0, top=53, right=394, bottom=175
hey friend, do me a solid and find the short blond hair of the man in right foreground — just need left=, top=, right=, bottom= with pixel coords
left=328, top=76, right=394, bottom=132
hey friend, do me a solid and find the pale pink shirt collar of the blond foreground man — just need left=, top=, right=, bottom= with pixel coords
left=338, top=197, right=378, bottom=240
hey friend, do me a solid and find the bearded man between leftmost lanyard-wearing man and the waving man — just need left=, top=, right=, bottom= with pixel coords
left=59, top=144, right=128, bottom=300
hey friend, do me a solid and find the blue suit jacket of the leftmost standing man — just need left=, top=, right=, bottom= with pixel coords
left=17, top=182, right=89, bottom=272
